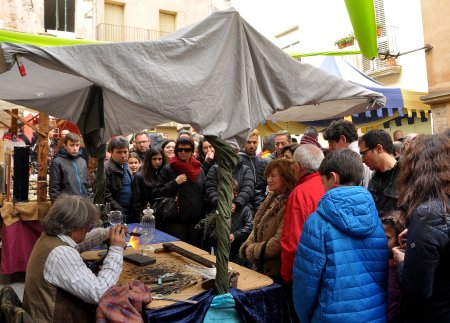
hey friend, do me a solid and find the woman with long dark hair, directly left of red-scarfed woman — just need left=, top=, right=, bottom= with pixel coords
left=132, top=147, right=166, bottom=221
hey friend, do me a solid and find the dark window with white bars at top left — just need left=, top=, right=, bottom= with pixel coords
left=44, top=0, right=75, bottom=32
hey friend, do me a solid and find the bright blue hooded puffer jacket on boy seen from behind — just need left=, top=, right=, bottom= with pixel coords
left=293, top=186, right=388, bottom=323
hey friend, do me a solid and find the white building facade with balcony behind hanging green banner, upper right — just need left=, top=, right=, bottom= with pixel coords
left=231, top=0, right=431, bottom=133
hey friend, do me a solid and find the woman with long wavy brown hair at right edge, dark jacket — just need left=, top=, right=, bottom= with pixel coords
left=393, top=134, right=450, bottom=322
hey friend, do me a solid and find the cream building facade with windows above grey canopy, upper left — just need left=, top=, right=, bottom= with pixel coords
left=0, top=0, right=230, bottom=41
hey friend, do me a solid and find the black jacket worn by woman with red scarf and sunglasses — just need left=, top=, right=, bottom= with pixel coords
left=153, top=164, right=205, bottom=223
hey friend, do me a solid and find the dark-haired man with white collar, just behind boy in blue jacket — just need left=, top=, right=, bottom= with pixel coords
left=323, top=119, right=372, bottom=188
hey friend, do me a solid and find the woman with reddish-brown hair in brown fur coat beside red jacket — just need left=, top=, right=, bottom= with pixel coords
left=239, top=158, right=295, bottom=281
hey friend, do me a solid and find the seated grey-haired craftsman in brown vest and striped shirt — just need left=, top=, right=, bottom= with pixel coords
left=23, top=195, right=127, bottom=322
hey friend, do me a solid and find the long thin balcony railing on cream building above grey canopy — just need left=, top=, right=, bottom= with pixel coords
left=97, top=23, right=169, bottom=42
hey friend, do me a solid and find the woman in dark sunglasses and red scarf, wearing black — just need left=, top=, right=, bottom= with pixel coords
left=154, top=136, right=205, bottom=246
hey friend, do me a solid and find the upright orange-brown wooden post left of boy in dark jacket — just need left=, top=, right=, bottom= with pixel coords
left=37, top=112, right=49, bottom=202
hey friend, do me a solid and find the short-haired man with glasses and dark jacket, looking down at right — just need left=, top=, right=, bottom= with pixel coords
left=359, top=129, right=399, bottom=217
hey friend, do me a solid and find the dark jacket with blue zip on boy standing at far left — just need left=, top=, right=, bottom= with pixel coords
left=49, top=148, right=94, bottom=203
